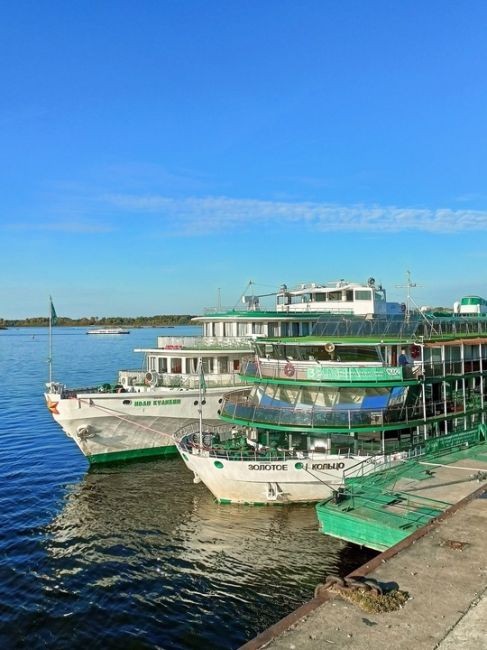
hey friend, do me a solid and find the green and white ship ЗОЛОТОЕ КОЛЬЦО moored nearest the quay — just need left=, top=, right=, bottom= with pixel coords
left=178, top=302, right=487, bottom=504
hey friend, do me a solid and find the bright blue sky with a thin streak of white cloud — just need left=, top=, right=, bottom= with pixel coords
left=0, top=0, right=487, bottom=318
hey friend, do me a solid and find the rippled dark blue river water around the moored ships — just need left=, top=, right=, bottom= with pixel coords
left=0, top=327, right=378, bottom=650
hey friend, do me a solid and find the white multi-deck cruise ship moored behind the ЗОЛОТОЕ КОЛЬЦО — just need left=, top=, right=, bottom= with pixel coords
left=45, top=278, right=401, bottom=463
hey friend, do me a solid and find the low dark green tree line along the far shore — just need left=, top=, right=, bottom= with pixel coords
left=0, top=314, right=198, bottom=328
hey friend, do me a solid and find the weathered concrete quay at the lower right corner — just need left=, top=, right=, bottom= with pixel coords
left=240, top=477, right=487, bottom=650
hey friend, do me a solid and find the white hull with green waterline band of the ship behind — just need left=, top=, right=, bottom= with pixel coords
left=45, top=388, right=231, bottom=462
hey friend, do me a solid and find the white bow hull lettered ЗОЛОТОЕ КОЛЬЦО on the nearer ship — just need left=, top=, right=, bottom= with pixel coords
left=178, top=444, right=384, bottom=504
